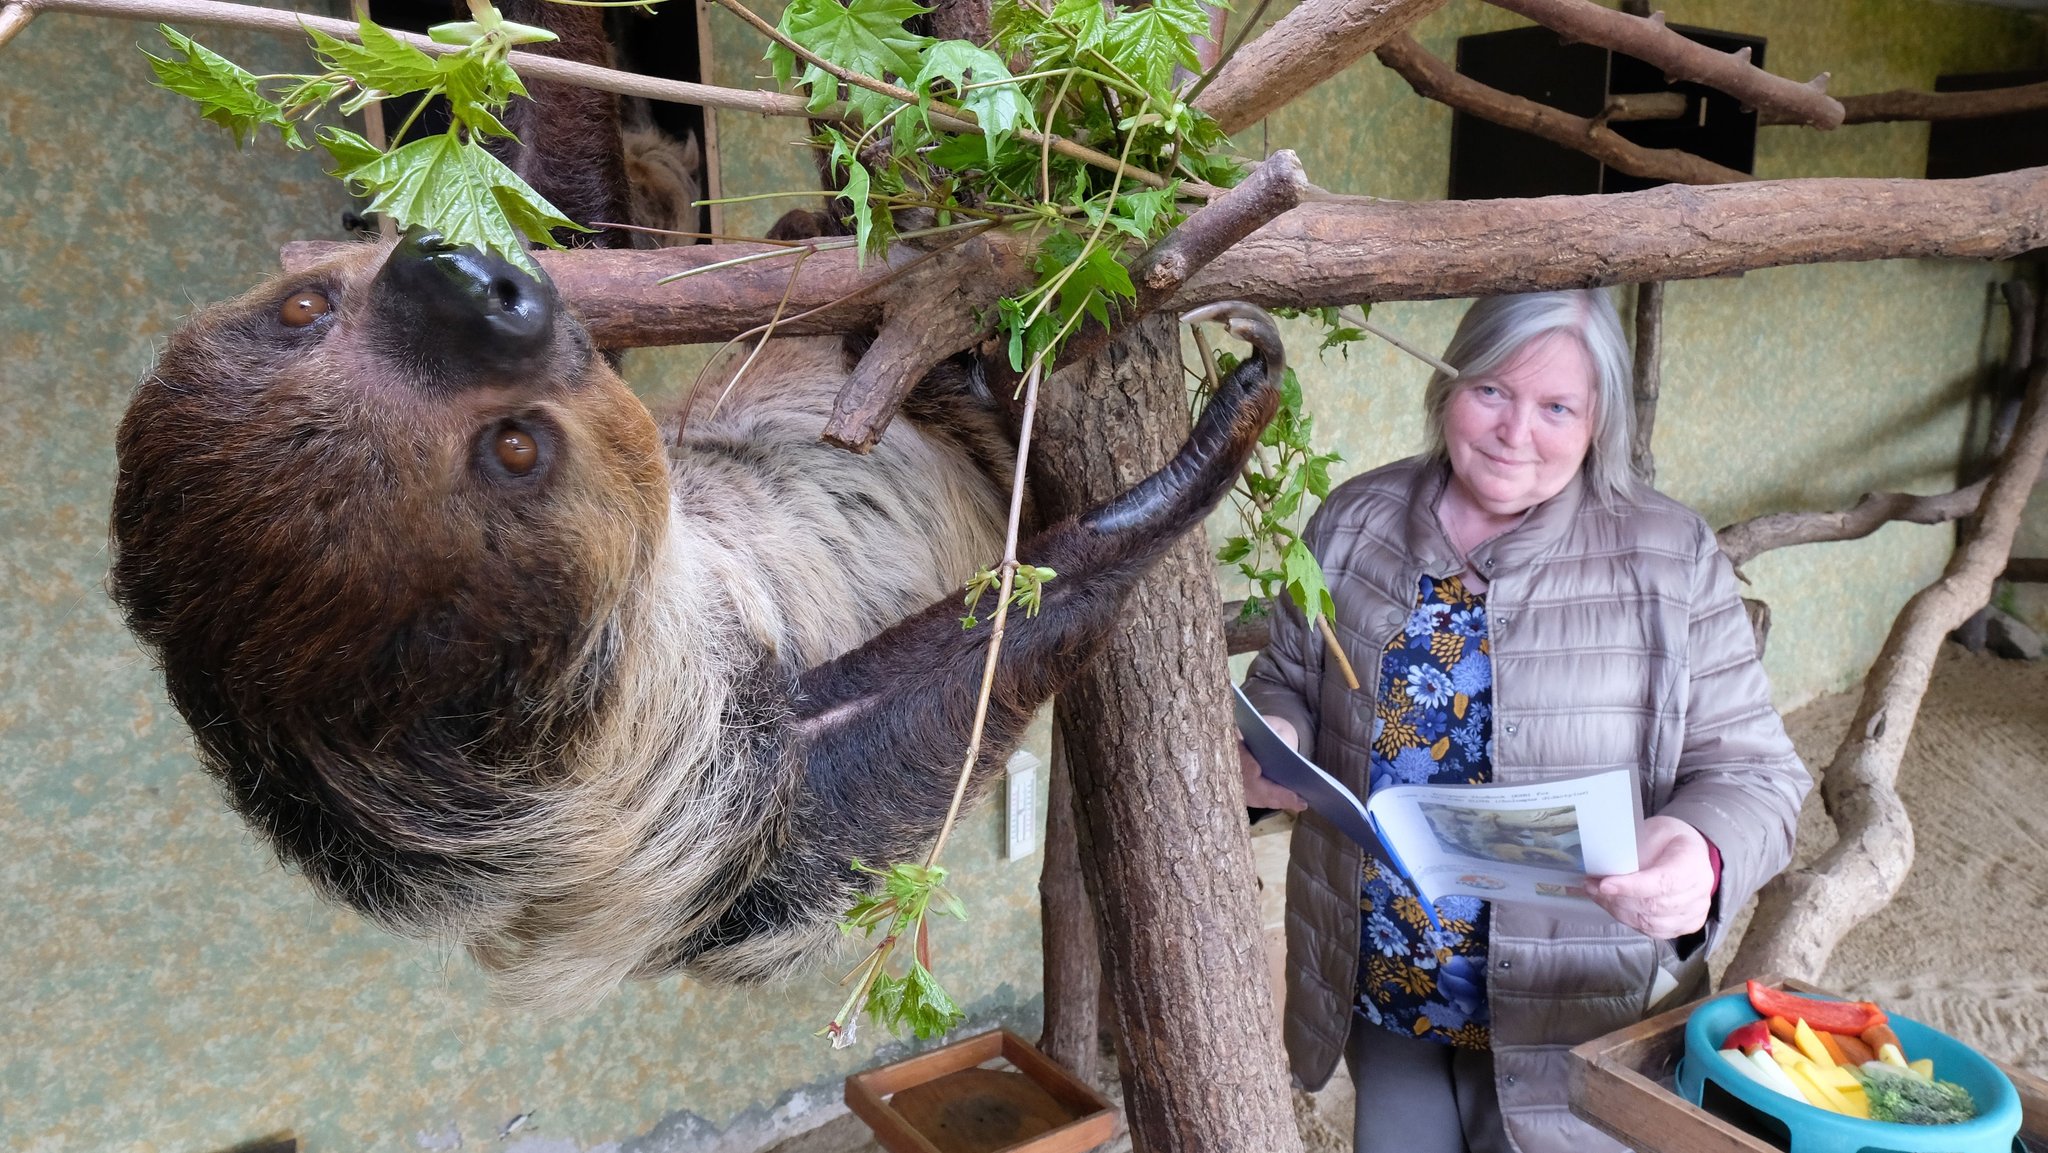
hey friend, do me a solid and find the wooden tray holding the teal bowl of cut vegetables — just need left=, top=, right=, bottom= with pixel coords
left=1569, top=977, right=2048, bottom=1153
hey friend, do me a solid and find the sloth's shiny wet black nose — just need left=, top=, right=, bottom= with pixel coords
left=373, top=229, right=557, bottom=377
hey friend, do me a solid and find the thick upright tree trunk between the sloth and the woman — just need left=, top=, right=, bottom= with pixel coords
left=1034, top=315, right=1300, bottom=1153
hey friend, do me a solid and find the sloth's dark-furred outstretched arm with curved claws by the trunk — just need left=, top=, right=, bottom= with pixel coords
left=672, top=305, right=1282, bottom=981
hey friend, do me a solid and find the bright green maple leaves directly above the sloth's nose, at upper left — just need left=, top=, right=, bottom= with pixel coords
left=150, top=0, right=588, bottom=270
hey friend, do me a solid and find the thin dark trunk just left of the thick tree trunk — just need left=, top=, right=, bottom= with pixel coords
left=1038, top=704, right=1102, bottom=1085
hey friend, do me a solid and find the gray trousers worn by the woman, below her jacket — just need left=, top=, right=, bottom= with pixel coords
left=1343, top=1018, right=1509, bottom=1153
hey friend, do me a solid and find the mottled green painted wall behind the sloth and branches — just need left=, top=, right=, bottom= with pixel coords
left=0, top=0, right=2048, bottom=1151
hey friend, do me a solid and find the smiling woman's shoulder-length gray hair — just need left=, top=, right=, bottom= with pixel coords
left=1421, top=289, right=1636, bottom=506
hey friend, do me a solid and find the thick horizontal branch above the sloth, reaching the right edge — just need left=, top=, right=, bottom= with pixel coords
left=285, top=168, right=2048, bottom=348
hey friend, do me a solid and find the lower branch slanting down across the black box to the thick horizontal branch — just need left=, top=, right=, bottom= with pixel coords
left=1378, top=35, right=1749, bottom=184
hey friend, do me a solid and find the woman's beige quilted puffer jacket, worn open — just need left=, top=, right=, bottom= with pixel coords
left=1245, top=459, right=1810, bottom=1153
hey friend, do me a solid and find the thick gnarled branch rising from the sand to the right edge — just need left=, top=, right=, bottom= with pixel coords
left=1729, top=350, right=2048, bottom=981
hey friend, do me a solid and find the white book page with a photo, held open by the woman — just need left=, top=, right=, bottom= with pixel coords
left=1366, top=768, right=1640, bottom=909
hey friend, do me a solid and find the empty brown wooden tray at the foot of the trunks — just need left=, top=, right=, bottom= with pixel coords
left=846, top=1028, right=1116, bottom=1153
